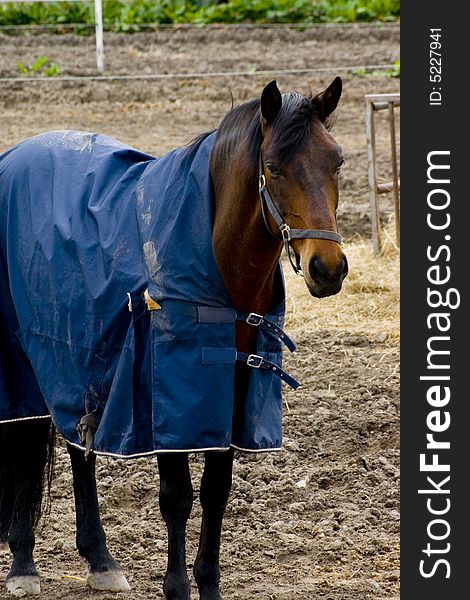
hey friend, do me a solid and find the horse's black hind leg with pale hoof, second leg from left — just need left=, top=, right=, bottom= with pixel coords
left=67, top=444, right=130, bottom=592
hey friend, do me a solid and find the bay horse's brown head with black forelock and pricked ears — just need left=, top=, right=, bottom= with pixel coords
left=260, top=77, right=348, bottom=298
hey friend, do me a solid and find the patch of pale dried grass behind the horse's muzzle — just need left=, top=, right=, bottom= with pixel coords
left=284, top=227, right=400, bottom=341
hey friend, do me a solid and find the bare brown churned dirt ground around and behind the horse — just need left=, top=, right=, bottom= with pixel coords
left=0, top=27, right=399, bottom=600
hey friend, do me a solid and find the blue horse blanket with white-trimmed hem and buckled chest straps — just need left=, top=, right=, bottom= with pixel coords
left=0, top=131, right=294, bottom=456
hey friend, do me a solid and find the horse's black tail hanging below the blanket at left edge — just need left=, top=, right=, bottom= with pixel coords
left=0, top=419, right=55, bottom=543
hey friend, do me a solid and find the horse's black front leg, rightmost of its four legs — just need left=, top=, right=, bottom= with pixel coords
left=194, top=449, right=233, bottom=600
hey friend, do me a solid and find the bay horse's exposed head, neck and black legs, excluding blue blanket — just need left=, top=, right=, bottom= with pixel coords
left=0, top=77, right=348, bottom=600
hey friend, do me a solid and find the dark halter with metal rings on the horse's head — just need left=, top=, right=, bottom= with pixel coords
left=259, top=155, right=343, bottom=276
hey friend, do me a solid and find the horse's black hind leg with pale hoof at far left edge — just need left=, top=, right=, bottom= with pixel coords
left=0, top=419, right=53, bottom=596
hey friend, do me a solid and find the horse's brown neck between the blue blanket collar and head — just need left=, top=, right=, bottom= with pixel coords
left=212, top=146, right=282, bottom=329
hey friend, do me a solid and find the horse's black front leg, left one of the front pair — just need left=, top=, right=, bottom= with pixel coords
left=158, top=454, right=193, bottom=600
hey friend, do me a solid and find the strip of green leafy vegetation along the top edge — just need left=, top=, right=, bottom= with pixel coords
left=0, top=0, right=400, bottom=31
